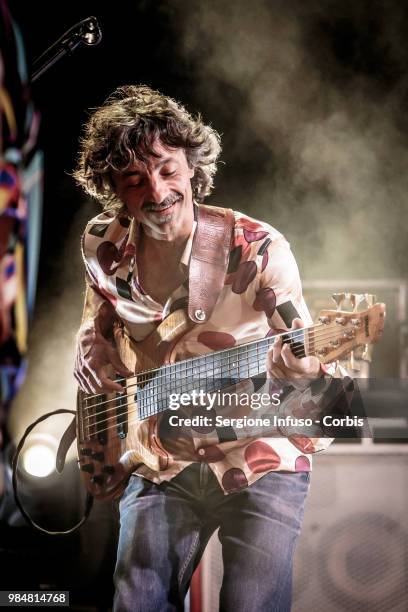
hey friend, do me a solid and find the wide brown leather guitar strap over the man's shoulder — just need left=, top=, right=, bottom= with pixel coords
left=188, top=204, right=235, bottom=324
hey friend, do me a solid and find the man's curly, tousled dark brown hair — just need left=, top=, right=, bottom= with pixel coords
left=73, top=85, right=221, bottom=212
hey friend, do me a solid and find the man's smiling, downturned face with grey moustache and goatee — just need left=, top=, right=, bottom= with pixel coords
left=113, top=141, right=194, bottom=240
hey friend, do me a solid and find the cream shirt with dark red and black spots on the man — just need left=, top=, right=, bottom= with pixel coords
left=82, top=212, right=342, bottom=493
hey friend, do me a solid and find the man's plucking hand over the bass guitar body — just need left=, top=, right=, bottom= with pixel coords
left=74, top=321, right=133, bottom=393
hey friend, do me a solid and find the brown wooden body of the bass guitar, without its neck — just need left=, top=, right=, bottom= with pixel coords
left=76, top=310, right=194, bottom=499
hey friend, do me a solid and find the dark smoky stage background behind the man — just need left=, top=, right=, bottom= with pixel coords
left=5, top=0, right=408, bottom=605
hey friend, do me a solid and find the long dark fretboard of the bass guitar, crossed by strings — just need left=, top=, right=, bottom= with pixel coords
left=136, top=330, right=308, bottom=419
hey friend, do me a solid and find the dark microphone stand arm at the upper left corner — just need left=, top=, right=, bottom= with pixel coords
left=31, top=17, right=102, bottom=83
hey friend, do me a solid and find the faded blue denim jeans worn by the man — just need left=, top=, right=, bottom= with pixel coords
left=114, top=463, right=309, bottom=612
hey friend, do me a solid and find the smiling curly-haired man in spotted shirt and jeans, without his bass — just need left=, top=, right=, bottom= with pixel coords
left=75, top=86, right=344, bottom=612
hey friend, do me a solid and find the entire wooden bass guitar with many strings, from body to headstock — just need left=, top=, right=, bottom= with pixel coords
left=76, top=304, right=385, bottom=499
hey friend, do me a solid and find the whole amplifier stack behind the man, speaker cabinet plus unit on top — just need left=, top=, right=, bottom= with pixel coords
left=199, top=279, right=408, bottom=612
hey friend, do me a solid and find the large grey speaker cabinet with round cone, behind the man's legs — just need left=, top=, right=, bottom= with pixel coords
left=201, top=452, right=408, bottom=612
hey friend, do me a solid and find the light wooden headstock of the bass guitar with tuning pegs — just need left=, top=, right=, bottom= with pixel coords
left=309, top=302, right=385, bottom=363
